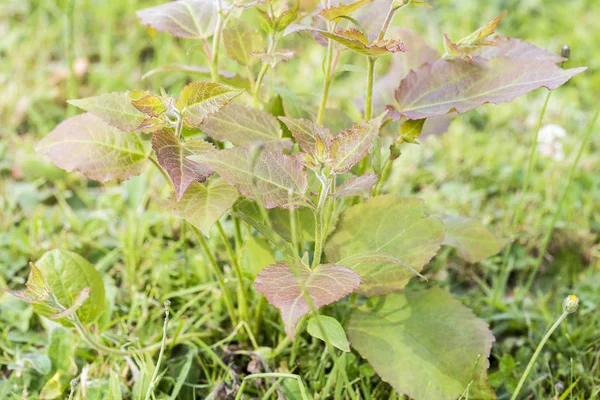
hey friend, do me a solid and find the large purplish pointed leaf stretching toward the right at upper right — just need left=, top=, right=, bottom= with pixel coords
left=392, top=56, right=586, bottom=119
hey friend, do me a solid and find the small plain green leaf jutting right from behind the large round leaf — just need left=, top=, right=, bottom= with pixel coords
left=443, top=217, right=507, bottom=263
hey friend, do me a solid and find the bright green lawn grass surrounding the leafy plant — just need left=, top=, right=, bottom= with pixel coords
left=0, top=0, right=600, bottom=399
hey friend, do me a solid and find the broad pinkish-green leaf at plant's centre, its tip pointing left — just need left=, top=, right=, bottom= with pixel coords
left=190, top=147, right=308, bottom=208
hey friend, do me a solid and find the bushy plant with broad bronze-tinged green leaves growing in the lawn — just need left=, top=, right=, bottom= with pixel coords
left=29, top=0, right=583, bottom=399
